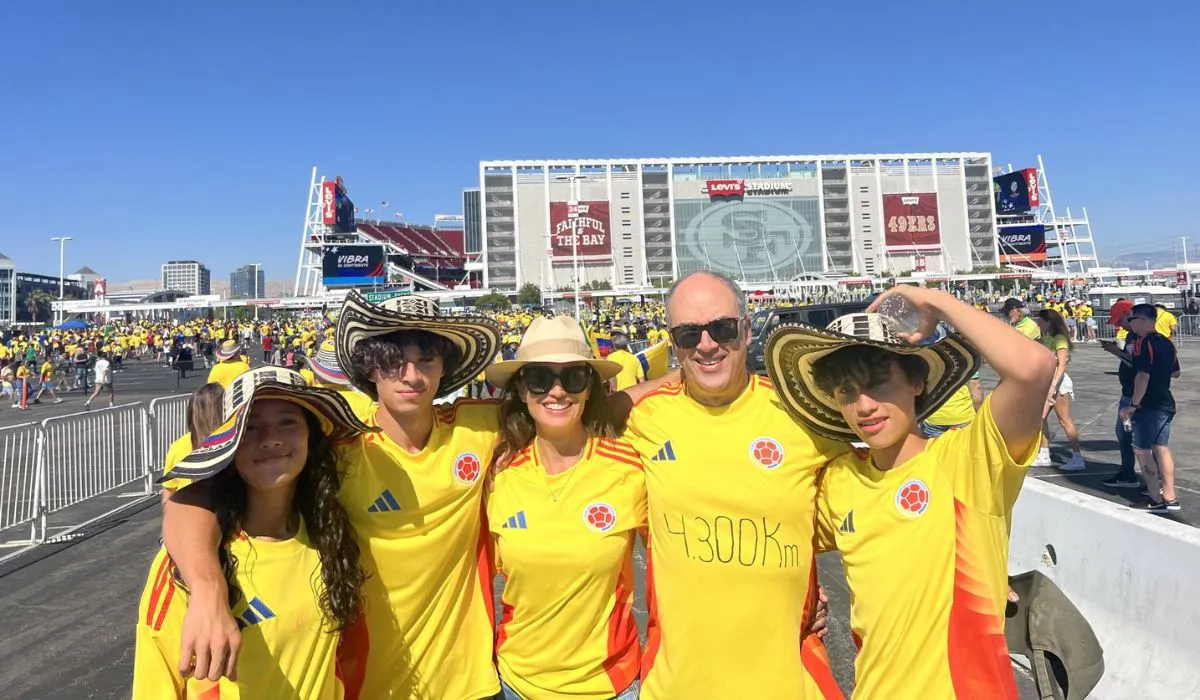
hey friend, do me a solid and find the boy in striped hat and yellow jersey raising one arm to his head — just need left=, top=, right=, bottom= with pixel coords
left=767, top=286, right=1055, bottom=700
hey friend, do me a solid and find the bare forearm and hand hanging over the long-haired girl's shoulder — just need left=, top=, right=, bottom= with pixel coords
left=162, top=483, right=241, bottom=681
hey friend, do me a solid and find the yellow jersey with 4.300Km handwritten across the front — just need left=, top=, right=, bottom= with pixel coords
left=628, top=377, right=848, bottom=700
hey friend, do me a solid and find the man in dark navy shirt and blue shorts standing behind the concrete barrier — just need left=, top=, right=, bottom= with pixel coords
left=1120, top=304, right=1180, bottom=513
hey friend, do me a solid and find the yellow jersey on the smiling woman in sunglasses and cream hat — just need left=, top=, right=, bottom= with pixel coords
left=487, top=438, right=646, bottom=700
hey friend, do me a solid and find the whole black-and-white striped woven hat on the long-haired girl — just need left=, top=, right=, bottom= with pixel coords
left=170, top=367, right=378, bottom=480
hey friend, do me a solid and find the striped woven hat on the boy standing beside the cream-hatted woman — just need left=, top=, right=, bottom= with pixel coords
left=334, top=291, right=500, bottom=396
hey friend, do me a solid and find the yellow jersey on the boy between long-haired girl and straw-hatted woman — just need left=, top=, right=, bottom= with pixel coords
left=340, top=400, right=499, bottom=700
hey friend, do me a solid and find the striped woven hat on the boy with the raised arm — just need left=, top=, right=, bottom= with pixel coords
left=766, top=313, right=980, bottom=442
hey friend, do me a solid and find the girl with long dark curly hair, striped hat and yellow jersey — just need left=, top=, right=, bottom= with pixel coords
left=133, top=367, right=368, bottom=700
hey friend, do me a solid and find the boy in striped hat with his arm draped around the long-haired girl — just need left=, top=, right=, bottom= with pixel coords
left=163, top=292, right=511, bottom=700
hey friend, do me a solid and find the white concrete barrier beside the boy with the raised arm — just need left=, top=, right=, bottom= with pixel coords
left=1008, top=479, right=1200, bottom=700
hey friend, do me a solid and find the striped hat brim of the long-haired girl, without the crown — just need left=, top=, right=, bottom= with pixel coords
left=168, top=382, right=378, bottom=481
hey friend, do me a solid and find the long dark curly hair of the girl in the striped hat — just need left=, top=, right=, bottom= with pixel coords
left=212, top=411, right=367, bottom=632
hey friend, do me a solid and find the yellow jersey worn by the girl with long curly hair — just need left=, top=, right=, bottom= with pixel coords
left=133, top=523, right=344, bottom=700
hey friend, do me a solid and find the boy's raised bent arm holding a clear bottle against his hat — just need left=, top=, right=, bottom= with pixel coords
left=868, top=285, right=1055, bottom=460
